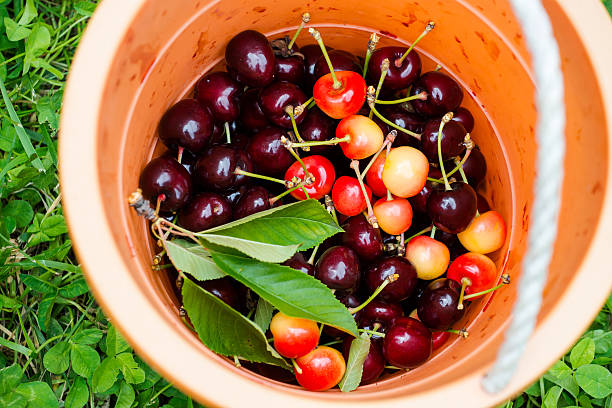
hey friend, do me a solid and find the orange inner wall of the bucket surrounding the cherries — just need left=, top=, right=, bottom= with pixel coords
left=98, top=0, right=608, bottom=398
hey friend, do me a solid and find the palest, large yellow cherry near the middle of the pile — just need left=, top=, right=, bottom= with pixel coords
left=382, top=146, right=429, bottom=198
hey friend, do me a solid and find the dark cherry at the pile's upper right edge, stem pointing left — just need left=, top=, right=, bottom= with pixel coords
left=410, top=71, right=463, bottom=116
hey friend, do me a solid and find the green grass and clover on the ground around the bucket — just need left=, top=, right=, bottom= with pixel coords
left=0, top=0, right=612, bottom=408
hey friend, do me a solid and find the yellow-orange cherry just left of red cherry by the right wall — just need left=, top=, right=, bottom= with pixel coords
left=405, top=235, right=450, bottom=280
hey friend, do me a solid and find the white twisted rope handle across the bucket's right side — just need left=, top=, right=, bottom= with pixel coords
left=482, top=0, right=565, bottom=393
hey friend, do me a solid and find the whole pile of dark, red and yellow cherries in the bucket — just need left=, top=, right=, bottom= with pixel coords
left=139, top=14, right=507, bottom=390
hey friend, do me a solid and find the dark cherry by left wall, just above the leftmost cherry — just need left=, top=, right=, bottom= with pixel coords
left=158, top=99, right=214, bottom=153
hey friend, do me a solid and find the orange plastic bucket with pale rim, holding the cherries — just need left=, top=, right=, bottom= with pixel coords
left=60, top=0, right=612, bottom=407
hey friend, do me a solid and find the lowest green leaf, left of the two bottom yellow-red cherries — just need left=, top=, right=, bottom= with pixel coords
left=183, top=279, right=290, bottom=369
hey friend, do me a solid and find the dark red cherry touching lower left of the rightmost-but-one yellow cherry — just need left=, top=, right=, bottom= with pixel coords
left=365, top=256, right=417, bottom=302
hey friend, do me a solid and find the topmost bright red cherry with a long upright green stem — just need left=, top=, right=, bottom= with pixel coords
left=312, top=71, right=366, bottom=119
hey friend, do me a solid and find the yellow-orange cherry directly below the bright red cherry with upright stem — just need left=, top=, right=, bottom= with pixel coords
left=336, top=115, right=385, bottom=160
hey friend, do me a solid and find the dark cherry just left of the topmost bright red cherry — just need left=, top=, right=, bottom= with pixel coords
left=259, top=81, right=308, bottom=128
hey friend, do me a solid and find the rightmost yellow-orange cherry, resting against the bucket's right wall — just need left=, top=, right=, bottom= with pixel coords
left=457, top=211, right=506, bottom=254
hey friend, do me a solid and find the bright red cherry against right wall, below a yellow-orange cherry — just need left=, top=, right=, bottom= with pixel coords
left=446, top=252, right=497, bottom=295
